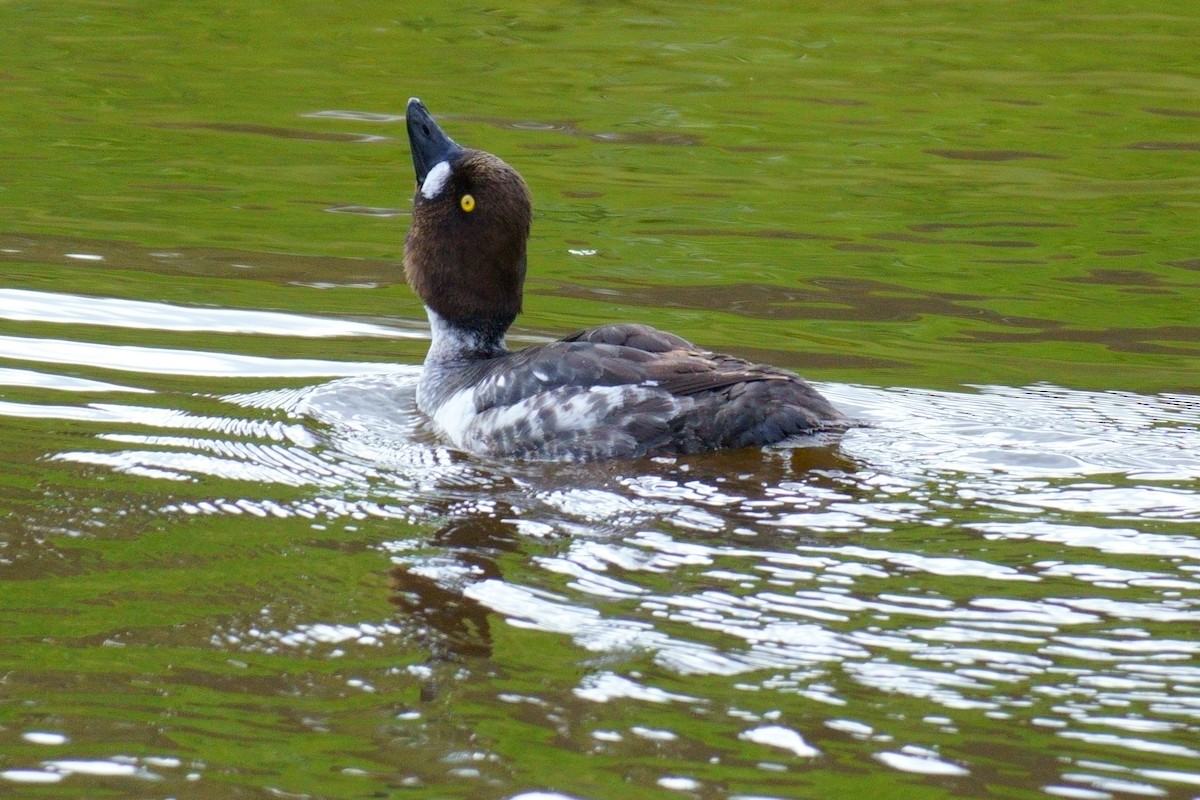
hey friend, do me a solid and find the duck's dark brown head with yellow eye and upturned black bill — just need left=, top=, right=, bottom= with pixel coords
left=404, top=97, right=533, bottom=335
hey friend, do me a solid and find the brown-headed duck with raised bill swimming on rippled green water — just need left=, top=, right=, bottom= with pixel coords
left=403, top=97, right=850, bottom=462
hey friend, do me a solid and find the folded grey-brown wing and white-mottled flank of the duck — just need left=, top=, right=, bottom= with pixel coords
left=451, top=325, right=847, bottom=459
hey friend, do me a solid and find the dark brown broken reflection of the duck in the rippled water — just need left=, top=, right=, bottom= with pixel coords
left=389, top=437, right=860, bottom=662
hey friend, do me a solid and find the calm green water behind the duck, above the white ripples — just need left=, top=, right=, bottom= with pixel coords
left=0, top=2, right=1200, bottom=391
